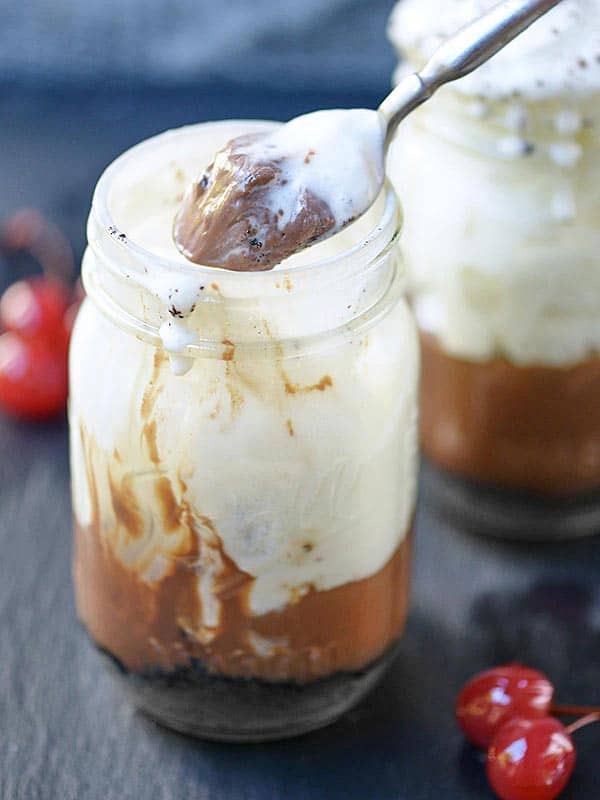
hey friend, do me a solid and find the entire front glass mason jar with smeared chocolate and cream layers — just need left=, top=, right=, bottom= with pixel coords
left=70, top=122, right=419, bottom=740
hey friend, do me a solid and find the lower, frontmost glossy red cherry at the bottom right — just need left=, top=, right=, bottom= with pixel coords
left=487, top=717, right=575, bottom=800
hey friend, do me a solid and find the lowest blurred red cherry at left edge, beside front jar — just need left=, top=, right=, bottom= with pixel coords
left=0, top=331, right=67, bottom=420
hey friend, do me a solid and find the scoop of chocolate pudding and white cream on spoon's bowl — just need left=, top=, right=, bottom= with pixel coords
left=173, top=109, right=385, bottom=271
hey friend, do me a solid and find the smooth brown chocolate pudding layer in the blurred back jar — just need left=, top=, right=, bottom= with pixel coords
left=421, top=334, right=600, bottom=497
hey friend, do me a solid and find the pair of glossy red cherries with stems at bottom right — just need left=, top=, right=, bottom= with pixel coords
left=456, top=664, right=600, bottom=800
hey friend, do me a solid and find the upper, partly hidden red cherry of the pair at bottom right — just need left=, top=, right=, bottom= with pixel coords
left=455, top=664, right=554, bottom=749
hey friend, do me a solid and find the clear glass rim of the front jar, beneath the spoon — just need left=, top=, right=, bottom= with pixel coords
left=88, top=119, right=402, bottom=293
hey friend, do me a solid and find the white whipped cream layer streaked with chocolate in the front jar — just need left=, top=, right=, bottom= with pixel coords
left=70, top=122, right=418, bottom=629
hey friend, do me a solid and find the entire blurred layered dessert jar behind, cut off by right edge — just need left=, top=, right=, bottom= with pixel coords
left=388, top=0, right=600, bottom=538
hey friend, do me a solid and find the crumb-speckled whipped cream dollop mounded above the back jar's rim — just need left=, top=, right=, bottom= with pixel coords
left=388, top=0, right=600, bottom=100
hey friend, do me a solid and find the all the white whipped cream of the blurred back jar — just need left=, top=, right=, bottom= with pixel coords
left=388, top=0, right=600, bottom=366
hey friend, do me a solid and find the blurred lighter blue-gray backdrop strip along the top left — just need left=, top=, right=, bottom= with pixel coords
left=0, top=0, right=394, bottom=92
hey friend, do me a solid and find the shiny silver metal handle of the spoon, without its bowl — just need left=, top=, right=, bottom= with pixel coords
left=379, top=0, right=560, bottom=144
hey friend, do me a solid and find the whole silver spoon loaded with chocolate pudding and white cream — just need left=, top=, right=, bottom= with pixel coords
left=173, top=0, right=560, bottom=271
